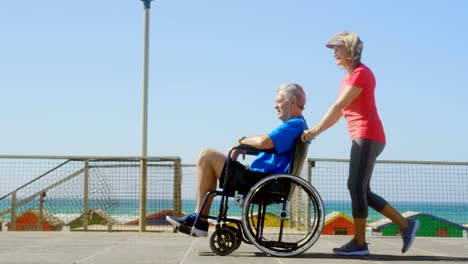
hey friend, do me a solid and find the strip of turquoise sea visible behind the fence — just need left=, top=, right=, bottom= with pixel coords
left=0, top=198, right=468, bottom=225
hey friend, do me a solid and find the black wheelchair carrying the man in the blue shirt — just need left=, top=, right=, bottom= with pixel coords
left=184, top=137, right=325, bottom=257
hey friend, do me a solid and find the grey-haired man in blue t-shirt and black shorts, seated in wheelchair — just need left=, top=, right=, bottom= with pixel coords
left=166, top=83, right=308, bottom=237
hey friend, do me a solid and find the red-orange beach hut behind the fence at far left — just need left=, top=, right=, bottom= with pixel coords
left=7, top=209, right=65, bottom=231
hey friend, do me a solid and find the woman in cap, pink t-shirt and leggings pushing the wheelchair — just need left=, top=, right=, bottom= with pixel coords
left=302, top=32, right=419, bottom=256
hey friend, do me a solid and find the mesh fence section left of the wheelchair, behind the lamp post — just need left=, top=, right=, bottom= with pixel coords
left=0, top=157, right=179, bottom=231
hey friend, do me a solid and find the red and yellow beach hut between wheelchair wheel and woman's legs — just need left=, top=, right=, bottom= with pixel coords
left=322, top=211, right=354, bottom=235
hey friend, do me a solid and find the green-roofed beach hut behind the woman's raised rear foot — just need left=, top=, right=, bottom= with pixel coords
left=369, top=211, right=468, bottom=237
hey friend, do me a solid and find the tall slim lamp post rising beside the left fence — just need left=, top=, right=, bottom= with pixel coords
left=139, top=0, right=152, bottom=232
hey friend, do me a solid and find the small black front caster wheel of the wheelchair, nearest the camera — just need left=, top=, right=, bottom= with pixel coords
left=210, top=227, right=239, bottom=256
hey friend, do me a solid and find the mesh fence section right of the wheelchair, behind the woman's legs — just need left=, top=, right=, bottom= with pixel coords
left=311, top=159, right=468, bottom=237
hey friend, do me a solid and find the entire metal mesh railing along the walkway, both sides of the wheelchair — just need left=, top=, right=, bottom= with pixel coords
left=0, top=156, right=468, bottom=236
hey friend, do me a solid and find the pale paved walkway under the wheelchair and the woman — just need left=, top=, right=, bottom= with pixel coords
left=0, top=232, right=468, bottom=264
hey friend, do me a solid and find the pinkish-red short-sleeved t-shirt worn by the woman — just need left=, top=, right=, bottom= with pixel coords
left=340, top=64, right=386, bottom=144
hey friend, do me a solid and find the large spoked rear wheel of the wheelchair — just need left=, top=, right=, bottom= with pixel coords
left=242, top=175, right=325, bottom=257
